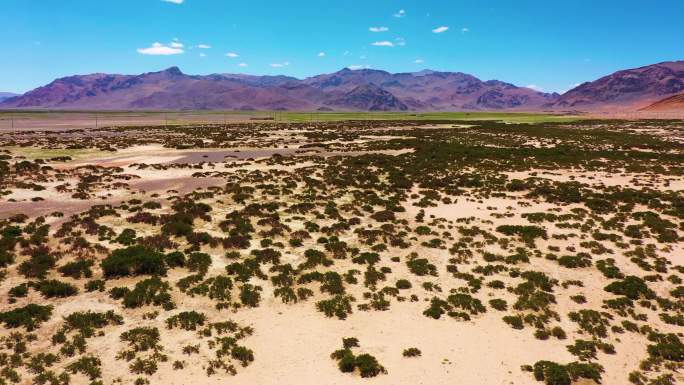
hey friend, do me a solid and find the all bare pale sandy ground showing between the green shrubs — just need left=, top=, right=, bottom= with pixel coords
left=0, top=122, right=684, bottom=385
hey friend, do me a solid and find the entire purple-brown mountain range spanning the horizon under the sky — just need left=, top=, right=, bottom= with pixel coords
left=0, top=61, right=684, bottom=111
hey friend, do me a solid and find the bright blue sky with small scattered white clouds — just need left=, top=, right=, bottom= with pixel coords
left=0, top=0, right=684, bottom=92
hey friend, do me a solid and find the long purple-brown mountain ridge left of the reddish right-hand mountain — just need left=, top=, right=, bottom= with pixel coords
left=0, top=67, right=558, bottom=111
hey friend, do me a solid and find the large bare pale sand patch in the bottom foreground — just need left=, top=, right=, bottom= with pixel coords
left=117, top=303, right=572, bottom=385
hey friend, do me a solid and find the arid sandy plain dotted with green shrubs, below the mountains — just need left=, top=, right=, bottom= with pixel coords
left=0, top=118, right=684, bottom=385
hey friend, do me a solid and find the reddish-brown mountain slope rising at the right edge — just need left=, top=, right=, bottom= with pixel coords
left=549, top=61, right=684, bottom=110
